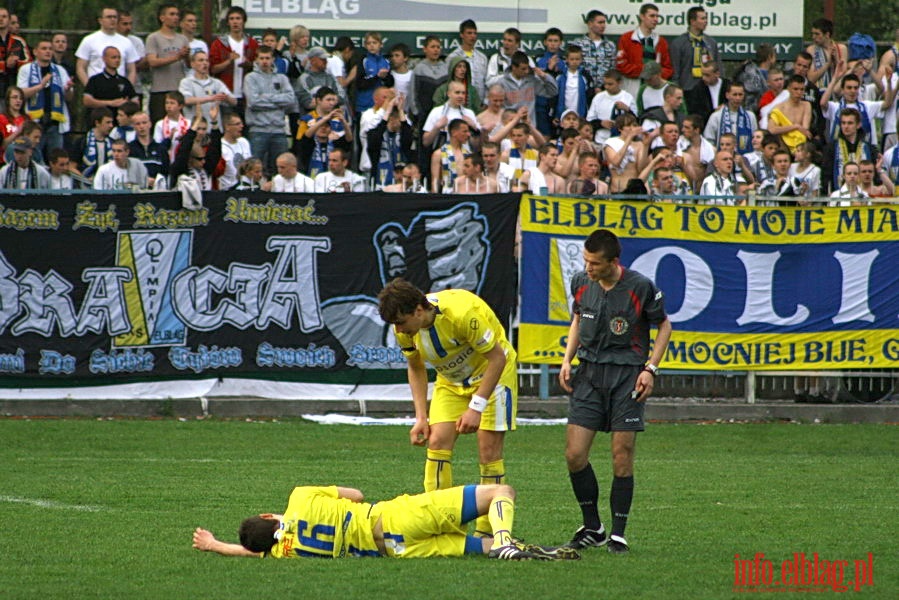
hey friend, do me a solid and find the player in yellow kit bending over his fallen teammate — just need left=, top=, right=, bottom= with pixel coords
left=378, top=279, right=518, bottom=536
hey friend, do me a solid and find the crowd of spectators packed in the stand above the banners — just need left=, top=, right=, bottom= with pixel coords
left=0, top=4, right=899, bottom=205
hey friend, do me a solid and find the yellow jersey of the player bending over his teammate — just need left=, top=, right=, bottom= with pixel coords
left=394, top=290, right=517, bottom=387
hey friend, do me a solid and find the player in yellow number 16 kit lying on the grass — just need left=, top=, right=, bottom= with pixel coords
left=193, top=485, right=580, bottom=560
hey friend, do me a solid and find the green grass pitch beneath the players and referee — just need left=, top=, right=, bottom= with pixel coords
left=0, top=419, right=899, bottom=600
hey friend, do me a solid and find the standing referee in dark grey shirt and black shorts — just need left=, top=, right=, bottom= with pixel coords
left=559, top=229, right=671, bottom=553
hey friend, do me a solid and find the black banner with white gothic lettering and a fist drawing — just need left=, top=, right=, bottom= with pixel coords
left=0, top=192, right=519, bottom=387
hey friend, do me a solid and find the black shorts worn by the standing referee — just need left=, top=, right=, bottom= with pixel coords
left=568, top=361, right=646, bottom=432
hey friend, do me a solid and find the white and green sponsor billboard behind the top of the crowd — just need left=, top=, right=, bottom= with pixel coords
left=234, top=0, right=805, bottom=60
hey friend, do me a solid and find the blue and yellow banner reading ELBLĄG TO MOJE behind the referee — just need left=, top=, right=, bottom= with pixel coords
left=518, top=195, right=899, bottom=371
